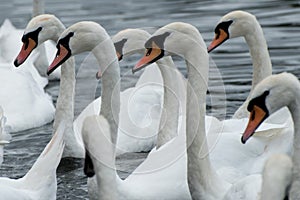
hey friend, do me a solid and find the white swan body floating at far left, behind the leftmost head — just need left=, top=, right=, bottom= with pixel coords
left=0, top=20, right=54, bottom=132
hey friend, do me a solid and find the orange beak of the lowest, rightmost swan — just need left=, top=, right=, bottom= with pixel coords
left=241, top=106, right=267, bottom=144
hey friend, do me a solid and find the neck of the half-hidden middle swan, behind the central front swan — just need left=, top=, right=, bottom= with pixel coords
left=156, top=56, right=185, bottom=149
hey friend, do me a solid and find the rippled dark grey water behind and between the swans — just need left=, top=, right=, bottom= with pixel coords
left=0, top=0, right=300, bottom=200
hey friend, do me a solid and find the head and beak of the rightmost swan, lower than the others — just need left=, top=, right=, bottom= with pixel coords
left=241, top=73, right=300, bottom=143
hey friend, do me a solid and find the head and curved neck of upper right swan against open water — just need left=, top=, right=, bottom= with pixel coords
left=208, top=10, right=272, bottom=118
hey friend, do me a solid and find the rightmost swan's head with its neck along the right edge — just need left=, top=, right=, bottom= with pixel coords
left=242, top=73, right=300, bottom=199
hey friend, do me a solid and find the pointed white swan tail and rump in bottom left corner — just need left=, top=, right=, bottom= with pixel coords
left=0, top=124, right=64, bottom=200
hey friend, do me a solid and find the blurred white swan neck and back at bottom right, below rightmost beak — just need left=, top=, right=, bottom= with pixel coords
left=224, top=154, right=293, bottom=200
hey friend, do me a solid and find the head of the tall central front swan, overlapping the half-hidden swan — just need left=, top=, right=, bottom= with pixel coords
left=132, top=22, right=206, bottom=72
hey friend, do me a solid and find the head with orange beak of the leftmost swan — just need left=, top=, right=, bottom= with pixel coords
left=14, top=14, right=64, bottom=67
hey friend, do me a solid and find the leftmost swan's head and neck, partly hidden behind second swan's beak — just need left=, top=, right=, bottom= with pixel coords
left=16, top=14, right=84, bottom=158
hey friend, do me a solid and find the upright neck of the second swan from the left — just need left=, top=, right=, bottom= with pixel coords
left=92, top=37, right=120, bottom=144
